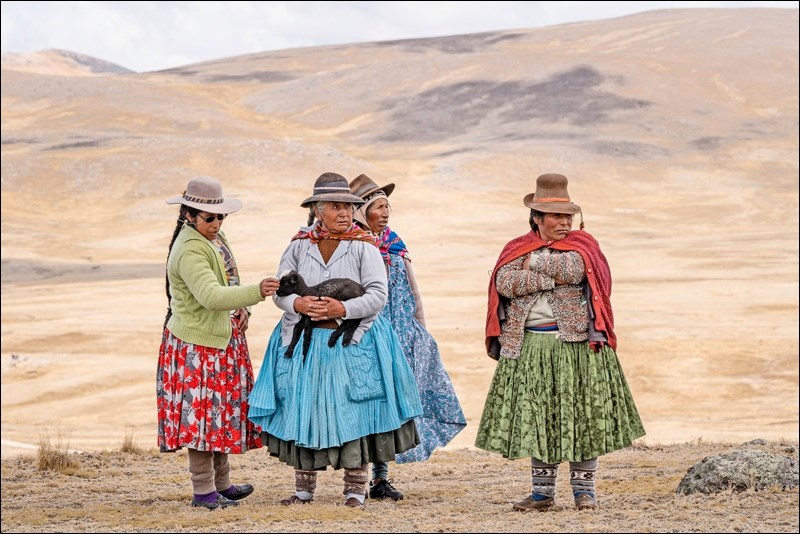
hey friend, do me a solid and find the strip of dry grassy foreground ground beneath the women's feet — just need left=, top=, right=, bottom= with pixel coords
left=2, top=439, right=798, bottom=532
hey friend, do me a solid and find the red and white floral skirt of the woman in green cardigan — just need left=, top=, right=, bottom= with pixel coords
left=156, top=319, right=262, bottom=454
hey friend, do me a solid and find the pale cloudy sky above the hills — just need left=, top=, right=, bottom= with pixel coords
left=0, top=0, right=799, bottom=72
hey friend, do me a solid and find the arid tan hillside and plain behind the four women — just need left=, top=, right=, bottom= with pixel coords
left=0, top=5, right=799, bottom=468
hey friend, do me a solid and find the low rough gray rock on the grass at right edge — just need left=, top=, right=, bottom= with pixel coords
left=676, top=450, right=798, bottom=495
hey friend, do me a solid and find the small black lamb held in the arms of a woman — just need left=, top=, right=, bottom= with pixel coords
left=275, top=271, right=366, bottom=360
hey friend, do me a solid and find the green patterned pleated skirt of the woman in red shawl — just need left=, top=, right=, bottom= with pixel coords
left=475, top=332, right=645, bottom=463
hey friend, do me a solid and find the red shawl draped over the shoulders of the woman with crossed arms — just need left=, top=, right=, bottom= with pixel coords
left=485, top=230, right=617, bottom=357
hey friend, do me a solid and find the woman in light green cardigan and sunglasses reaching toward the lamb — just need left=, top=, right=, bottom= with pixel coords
left=156, top=176, right=279, bottom=510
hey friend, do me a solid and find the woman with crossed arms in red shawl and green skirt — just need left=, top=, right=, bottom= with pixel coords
left=475, top=173, right=644, bottom=512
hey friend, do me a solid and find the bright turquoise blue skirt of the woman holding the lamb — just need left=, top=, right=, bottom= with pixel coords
left=248, top=316, right=422, bottom=449
